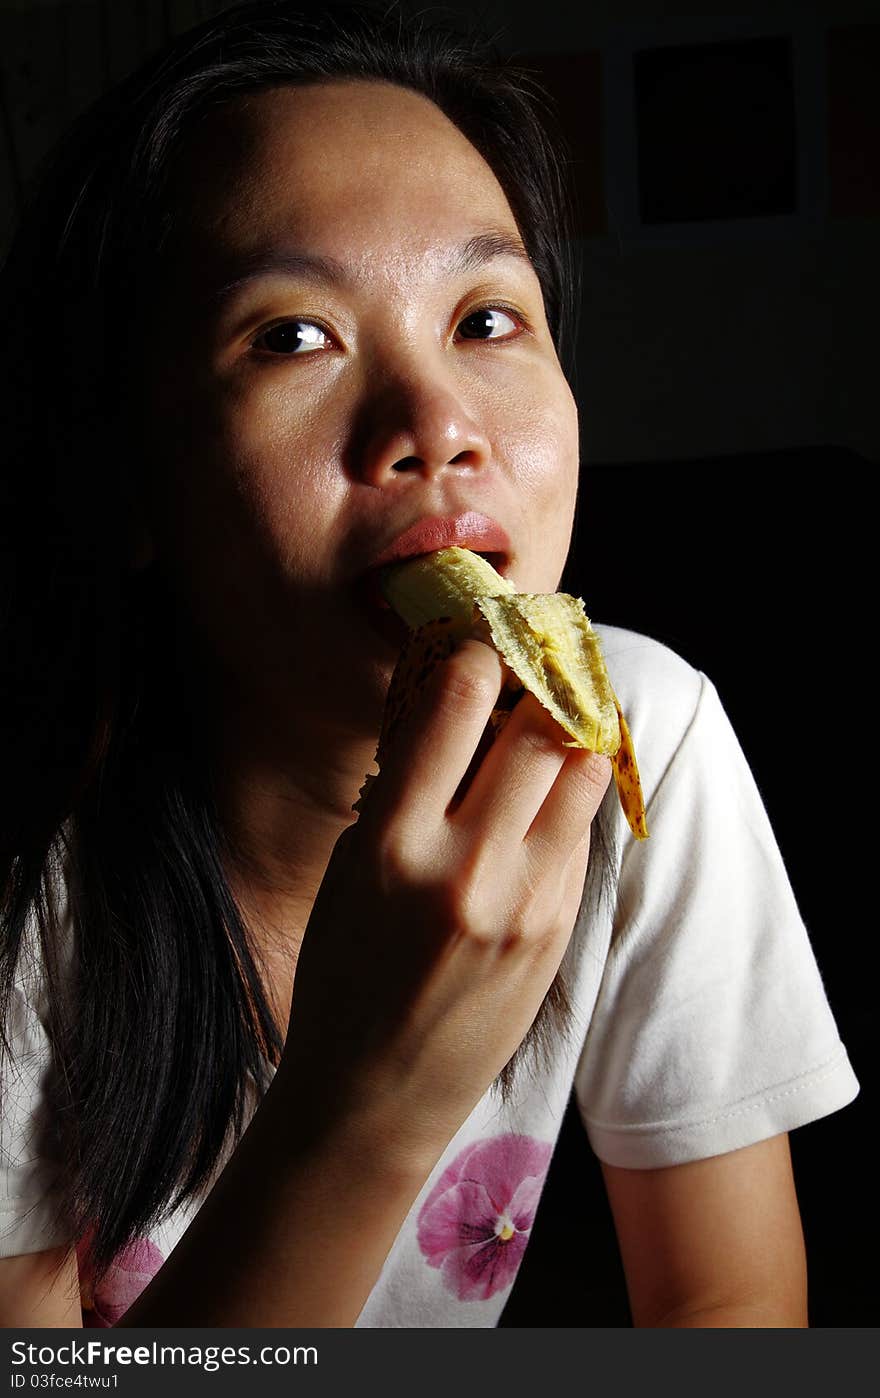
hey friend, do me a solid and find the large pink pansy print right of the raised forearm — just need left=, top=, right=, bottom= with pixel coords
left=418, top=1132, right=553, bottom=1302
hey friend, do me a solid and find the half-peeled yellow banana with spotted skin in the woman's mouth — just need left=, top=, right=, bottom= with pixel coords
left=353, top=548, right=648, bottom=840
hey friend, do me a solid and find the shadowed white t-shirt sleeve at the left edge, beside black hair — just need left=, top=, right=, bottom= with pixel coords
left=0, top=928, right=70, bottom=1257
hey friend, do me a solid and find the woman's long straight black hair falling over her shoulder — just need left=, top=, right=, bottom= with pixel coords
left=0, top=0, right=609, bottom=1302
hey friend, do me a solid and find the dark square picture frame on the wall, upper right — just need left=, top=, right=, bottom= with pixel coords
left=603, top=15, right=827, bottom=247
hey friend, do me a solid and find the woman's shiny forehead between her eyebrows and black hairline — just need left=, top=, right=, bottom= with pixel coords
left=166, top=81, right=516, bottom=280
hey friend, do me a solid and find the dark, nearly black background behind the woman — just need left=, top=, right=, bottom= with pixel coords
left=0, top=0, right=880, bottom=1327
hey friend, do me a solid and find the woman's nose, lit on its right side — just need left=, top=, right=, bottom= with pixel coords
left=353, top=372, right=491, bottom=487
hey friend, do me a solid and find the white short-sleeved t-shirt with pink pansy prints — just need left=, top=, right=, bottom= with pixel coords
left=0, top=626, right=858, bottom=1328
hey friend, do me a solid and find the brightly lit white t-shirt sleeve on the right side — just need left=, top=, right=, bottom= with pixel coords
left=575, top=671, right=859, bottom=1169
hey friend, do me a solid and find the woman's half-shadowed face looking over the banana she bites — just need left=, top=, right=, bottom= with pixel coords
left=133, top=81, right=578, bottom=737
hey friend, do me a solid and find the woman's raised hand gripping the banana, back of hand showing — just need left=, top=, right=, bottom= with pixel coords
left=278, top=640, right=611, bottom=1169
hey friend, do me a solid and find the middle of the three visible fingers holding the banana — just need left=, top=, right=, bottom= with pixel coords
left=456, top=693, right=567, bottom=844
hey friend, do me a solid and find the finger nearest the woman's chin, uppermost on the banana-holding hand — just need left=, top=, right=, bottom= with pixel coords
left=382, top=639, right=504, bottom=819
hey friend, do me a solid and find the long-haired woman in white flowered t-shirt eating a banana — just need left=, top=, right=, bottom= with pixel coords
left=0, top=3, right=856, bottom=1327
